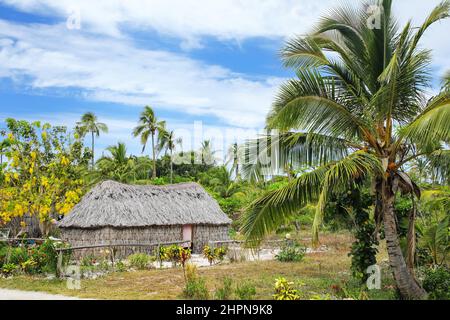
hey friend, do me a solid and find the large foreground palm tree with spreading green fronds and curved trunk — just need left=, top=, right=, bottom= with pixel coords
left=243, top=0, right=450, bottom=299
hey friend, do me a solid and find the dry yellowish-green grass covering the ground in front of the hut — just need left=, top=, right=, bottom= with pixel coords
left=0, top=233, right=394, bottom=300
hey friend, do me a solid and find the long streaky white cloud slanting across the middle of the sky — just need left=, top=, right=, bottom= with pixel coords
left=0, top=20, right=281, bottom=127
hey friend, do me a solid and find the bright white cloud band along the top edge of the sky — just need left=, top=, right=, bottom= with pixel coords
left=2, top=0, right=336, bottom=41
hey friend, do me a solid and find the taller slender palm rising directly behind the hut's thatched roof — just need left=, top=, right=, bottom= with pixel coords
left=133, top=106, right=166, bottom=179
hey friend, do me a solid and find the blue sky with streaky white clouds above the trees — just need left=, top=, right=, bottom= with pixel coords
left=0, top=0, right=450, bottom=157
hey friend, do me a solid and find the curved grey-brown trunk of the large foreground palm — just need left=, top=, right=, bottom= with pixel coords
left=382, top=178, right=427, bottom=299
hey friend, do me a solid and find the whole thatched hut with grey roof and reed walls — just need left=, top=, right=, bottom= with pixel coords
left=58, top=181, right=231, bottom=255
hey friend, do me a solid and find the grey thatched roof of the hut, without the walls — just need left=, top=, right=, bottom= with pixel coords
left=59, top=181, right=231, bottom=228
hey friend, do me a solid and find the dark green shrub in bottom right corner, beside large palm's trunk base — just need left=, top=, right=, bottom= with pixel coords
left=423, top=266, right=450, bottom=300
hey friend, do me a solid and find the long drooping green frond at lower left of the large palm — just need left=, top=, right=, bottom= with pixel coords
left=242, top=151, right=382, bottom=241
